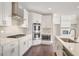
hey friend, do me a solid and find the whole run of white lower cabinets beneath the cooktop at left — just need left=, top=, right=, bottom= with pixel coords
left=0, top=35, right=32, bottom=56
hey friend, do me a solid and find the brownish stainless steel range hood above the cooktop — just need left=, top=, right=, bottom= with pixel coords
left=12, top=2, right=24, bottom=18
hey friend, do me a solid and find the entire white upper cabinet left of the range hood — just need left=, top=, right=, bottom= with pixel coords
left=0, top=2, right=12, bottom=26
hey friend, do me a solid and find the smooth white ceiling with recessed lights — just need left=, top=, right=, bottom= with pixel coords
left=22, top=2, right=79, bottom=14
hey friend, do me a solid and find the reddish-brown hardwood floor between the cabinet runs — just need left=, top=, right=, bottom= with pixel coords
left=23, top=44, right=54, bottom=56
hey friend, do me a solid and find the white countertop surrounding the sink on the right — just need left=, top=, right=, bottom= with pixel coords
left=56, top=36, right=79, bottom=56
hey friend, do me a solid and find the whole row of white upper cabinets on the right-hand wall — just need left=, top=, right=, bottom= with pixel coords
left=53, top=14, right=77, bottom=27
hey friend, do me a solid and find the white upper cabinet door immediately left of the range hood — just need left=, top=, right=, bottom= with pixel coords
left=2, top=2, right=12, bottom=26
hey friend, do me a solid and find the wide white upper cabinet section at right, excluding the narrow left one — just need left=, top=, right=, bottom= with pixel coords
left=61, top=15, right=77, bottom=27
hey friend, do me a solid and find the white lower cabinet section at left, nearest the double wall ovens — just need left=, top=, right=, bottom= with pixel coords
left=19, top=35, right=32, bottom=56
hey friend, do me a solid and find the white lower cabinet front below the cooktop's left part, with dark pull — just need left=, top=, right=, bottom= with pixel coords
left=3, top=40, right=18, bottom=56
